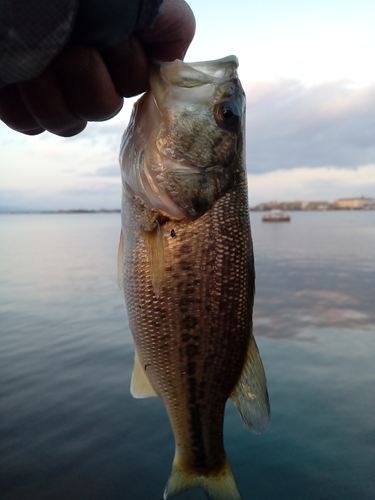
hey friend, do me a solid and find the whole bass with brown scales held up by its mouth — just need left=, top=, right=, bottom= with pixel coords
left=118, top=56, right=270, bottom=500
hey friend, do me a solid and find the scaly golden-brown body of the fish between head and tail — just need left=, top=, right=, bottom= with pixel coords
left=126, top=190, right=252, bottom=470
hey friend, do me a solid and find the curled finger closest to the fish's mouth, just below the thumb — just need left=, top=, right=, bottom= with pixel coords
left=101, top=36, right=149, bottom=97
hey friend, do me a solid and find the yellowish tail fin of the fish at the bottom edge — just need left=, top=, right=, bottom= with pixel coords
left=164, top=461, right=242, bottom=500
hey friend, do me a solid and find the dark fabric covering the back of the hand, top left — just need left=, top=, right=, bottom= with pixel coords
left=0, top=0, right=162, bottom=88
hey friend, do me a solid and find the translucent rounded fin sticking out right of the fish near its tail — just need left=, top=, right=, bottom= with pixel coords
left=231, top=335, right=271, bottom=433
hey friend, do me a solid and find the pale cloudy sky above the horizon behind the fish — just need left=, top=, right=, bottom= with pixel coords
left=0, top=0, right=375, bottom=210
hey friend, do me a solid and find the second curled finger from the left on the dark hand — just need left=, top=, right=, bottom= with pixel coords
left=18, top=68, right=86, bottom=137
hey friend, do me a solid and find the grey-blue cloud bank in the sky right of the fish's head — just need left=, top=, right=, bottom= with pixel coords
left=245, top=80, right=375, bottom=173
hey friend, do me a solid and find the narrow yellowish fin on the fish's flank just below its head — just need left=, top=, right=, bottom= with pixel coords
left=143, top=221, right=164, bottom=298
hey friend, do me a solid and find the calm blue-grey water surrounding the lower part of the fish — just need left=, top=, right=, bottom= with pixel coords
left=0, top=212, right=375, bottom=500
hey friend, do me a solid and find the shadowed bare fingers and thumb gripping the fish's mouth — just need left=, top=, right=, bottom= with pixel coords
left=0, top=0, right=195, bottom=137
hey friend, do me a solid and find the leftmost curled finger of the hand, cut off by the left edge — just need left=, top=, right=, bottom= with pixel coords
left=0, top=85, right=45, bottom=135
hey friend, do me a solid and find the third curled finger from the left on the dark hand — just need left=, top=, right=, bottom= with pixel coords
left=54, top=47, right=123, bottom=121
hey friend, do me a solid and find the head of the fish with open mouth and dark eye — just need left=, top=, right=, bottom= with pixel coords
left=121, top=56, right=245, bottom=219
